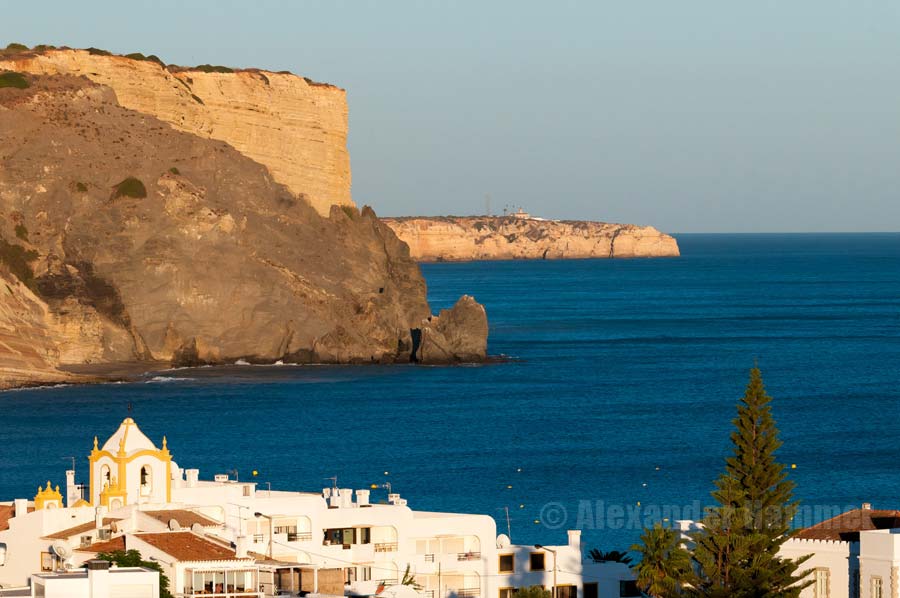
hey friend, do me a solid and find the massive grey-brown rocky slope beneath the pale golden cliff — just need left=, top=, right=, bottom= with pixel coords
left=0, top=76, right=486, bottom=376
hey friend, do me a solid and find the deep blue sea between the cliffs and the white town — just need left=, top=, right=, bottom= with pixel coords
left=0, top=234, right=900, bottom=550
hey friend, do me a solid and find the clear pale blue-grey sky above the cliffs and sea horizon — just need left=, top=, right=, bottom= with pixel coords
left=0, top=0, right=900, bottom=232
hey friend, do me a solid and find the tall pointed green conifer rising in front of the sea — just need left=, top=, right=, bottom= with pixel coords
left=691, top=367, right=811, bottom=598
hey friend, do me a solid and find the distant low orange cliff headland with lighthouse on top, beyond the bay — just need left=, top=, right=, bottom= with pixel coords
left=384, top=216, right=679, bottom=262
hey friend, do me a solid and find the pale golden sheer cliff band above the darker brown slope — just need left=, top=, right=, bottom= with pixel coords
left=0, top=50, right=353, bottom=216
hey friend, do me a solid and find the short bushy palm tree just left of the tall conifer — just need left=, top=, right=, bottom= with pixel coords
left=631, top=523, right=692, bottom=598
